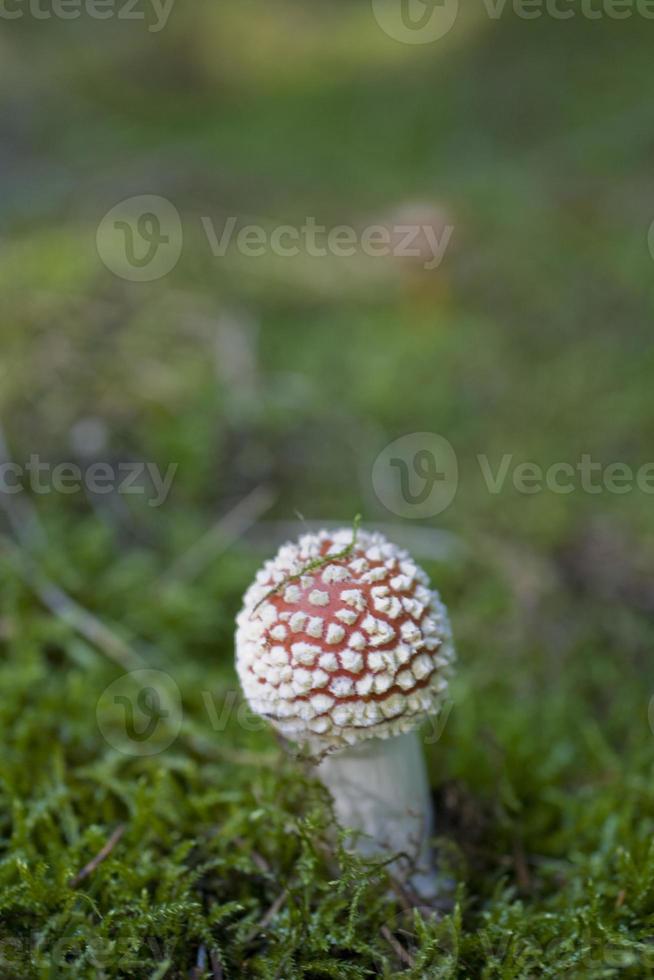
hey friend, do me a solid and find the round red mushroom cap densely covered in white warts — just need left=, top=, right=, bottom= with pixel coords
left=236, top=529, right=454, bottom=754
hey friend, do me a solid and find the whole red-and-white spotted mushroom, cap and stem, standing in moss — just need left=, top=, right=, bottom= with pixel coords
left=236, top=527, right=454, bottom=898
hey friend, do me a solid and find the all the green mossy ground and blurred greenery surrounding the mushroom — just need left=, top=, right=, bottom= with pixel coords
left=0, top=0, right=654, bottom=980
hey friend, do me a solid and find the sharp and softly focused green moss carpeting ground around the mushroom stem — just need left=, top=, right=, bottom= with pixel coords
left=0, top=524, right=654, bottom=978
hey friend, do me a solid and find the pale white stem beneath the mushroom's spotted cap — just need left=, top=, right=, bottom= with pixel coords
left=317, top=731, right=439, bottom=898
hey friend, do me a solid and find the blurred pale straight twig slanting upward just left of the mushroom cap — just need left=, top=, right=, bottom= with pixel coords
left=157, top=485, right=276, bottom=587
